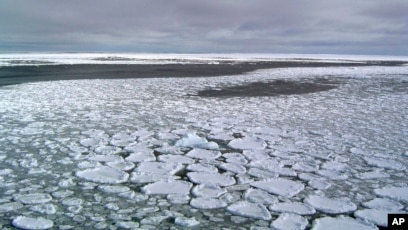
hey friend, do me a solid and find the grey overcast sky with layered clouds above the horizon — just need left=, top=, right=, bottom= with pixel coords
left=0, top=0, right=408, bottom=55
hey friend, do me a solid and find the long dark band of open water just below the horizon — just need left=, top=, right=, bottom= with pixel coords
left=0, top=61, right=407, bottom=87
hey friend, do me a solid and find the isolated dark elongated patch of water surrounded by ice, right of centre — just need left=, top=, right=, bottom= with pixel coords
left=197, top=78, right=340, bottom=97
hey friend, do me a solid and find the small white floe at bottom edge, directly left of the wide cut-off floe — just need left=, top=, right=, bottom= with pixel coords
left=271, top=213, right=309, bottom=230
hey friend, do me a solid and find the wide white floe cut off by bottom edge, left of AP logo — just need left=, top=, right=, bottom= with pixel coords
left=312, top=216, right=378, bottom=230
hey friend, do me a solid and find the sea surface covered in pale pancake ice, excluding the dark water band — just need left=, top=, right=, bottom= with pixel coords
left=0, top=54, right=408, bottom=229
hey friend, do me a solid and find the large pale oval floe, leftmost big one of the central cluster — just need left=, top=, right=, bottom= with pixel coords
left=76, top=166, right=129, bottom=184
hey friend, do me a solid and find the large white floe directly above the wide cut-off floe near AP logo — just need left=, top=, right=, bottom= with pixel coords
left=305, top=195, right=357, bottom=214
